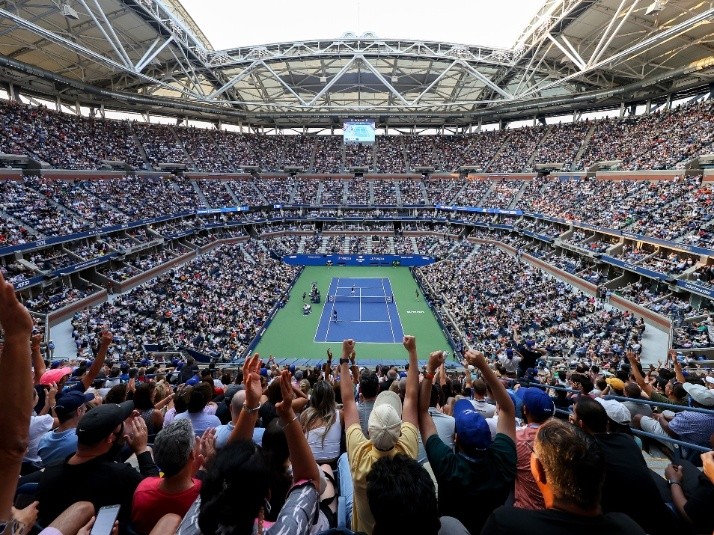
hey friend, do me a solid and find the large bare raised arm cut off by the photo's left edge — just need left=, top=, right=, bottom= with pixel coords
left=0, top=272, right=33, bottom=522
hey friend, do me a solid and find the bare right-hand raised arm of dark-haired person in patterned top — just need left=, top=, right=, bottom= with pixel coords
left=275, top=370, right=320, bottom=488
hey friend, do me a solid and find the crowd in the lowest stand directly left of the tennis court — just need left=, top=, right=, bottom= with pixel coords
left=75, top=245, right=295, bottom=358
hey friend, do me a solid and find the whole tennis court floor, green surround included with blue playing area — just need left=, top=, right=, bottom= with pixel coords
left=254, top=266, right=449, bottom=366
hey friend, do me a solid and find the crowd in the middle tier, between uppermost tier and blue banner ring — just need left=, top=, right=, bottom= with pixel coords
left=5, top=176, right=714, bottom=252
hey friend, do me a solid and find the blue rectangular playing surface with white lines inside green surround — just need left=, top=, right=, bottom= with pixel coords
left=315, top=277, right=404, bottom=344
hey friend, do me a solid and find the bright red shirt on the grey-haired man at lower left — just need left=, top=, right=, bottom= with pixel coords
left=131, top=477, right=201, bottom=534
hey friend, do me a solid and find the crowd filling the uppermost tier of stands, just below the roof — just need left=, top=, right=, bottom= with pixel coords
left=0, top=100, right=714, bottom=173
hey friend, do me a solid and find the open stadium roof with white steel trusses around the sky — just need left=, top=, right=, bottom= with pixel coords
left=0, top=0, right=714, bottom=127
